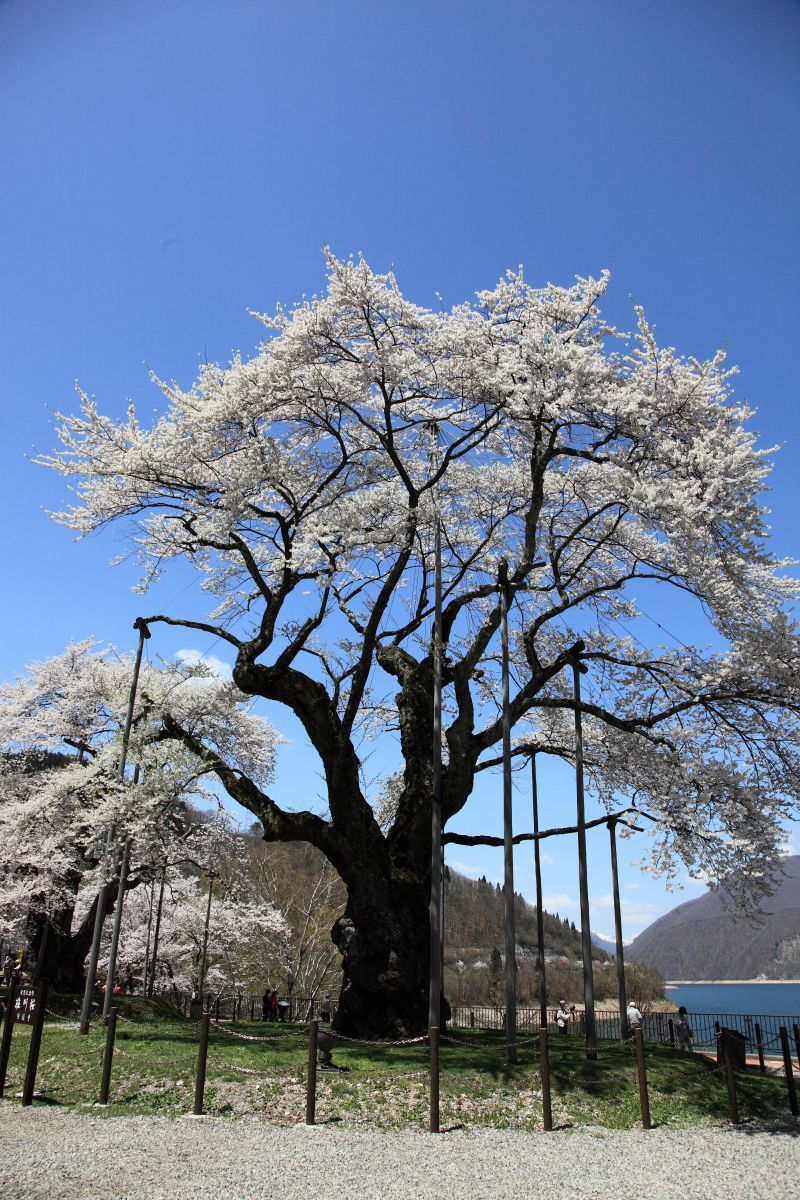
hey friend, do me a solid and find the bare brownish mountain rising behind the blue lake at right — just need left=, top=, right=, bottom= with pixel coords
left=626, top=854, right=800, bottom=979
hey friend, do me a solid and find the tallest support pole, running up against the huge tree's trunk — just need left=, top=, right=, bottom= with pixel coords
left=428, top=512, right=443, bottom=1030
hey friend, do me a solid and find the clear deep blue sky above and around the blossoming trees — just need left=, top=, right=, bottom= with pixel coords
left=0, top=0, right=800, bottom=936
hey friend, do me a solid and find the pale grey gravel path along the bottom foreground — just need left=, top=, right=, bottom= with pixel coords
left=0, top=1104, right=800, bottom=1200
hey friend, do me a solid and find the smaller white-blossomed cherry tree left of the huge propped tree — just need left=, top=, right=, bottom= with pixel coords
left=0, top=641, right=281, bottom=991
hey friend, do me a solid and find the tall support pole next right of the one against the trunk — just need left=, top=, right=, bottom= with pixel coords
left=498, top=560, right=517, bottom=1062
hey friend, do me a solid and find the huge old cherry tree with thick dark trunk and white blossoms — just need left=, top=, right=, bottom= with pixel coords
left=41, top=254, right=800, bottom=1032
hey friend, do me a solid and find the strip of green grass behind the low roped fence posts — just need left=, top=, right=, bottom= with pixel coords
left=5, top=1004, right=789, bottom=1129
